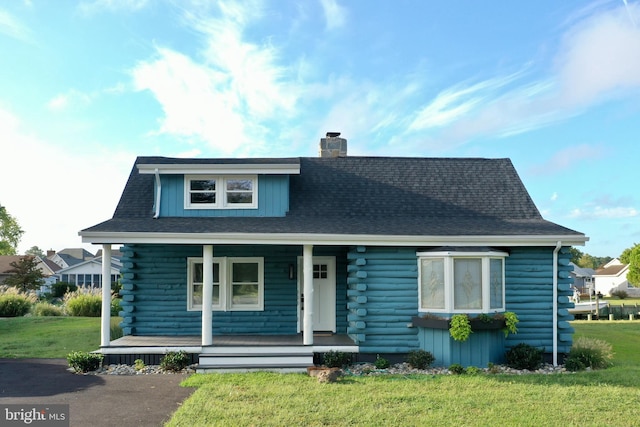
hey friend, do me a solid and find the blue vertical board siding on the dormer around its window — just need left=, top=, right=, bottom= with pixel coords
left=154, top=175, right=289, bottom=217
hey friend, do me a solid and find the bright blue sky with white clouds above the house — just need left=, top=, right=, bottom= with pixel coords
left=0, top=0, right=640, bottom=257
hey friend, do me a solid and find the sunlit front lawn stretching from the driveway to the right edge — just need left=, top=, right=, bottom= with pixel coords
left=167, top=321, right=640, bottom=426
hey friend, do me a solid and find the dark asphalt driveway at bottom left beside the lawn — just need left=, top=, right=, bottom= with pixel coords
left=0, top=359, right=194, bottom=427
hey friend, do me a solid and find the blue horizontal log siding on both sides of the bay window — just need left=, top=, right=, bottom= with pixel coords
left=347, top=246, right=573, bottom=363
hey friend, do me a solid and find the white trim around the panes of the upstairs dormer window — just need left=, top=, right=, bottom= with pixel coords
left=184, top=175, right=258, bottom=209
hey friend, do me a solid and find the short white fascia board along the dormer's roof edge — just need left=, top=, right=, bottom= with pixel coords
left=137, top=163, right=300, bottom=175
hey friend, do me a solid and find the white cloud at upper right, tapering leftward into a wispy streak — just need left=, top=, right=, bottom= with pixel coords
left=406, top=5, right=640, bottom=144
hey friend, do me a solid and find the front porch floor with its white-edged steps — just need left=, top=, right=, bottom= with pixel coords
left=100, top=334, right=359, bottom=373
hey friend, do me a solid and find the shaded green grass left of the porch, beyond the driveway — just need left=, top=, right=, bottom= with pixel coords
left=0, top=317, right=120, bottom=358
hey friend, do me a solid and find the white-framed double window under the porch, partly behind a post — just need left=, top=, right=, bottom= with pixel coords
left=187, top=257, right=264, bottom=311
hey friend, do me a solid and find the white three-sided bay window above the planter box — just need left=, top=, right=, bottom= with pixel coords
left=417, top=250, right=508, bottom=313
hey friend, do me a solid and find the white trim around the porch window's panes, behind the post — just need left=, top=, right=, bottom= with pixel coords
left=187, top=257, right=264, bottom=311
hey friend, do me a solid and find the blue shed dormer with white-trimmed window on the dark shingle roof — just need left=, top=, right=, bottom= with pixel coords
left=136, top=158, right=300, bottom=218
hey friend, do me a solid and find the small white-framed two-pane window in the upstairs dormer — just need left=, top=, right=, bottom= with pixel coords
left=184, top=175, right=258, bottom=209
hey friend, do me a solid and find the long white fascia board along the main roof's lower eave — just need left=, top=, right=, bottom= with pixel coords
left=80, top=232, right=589, bottom=247
